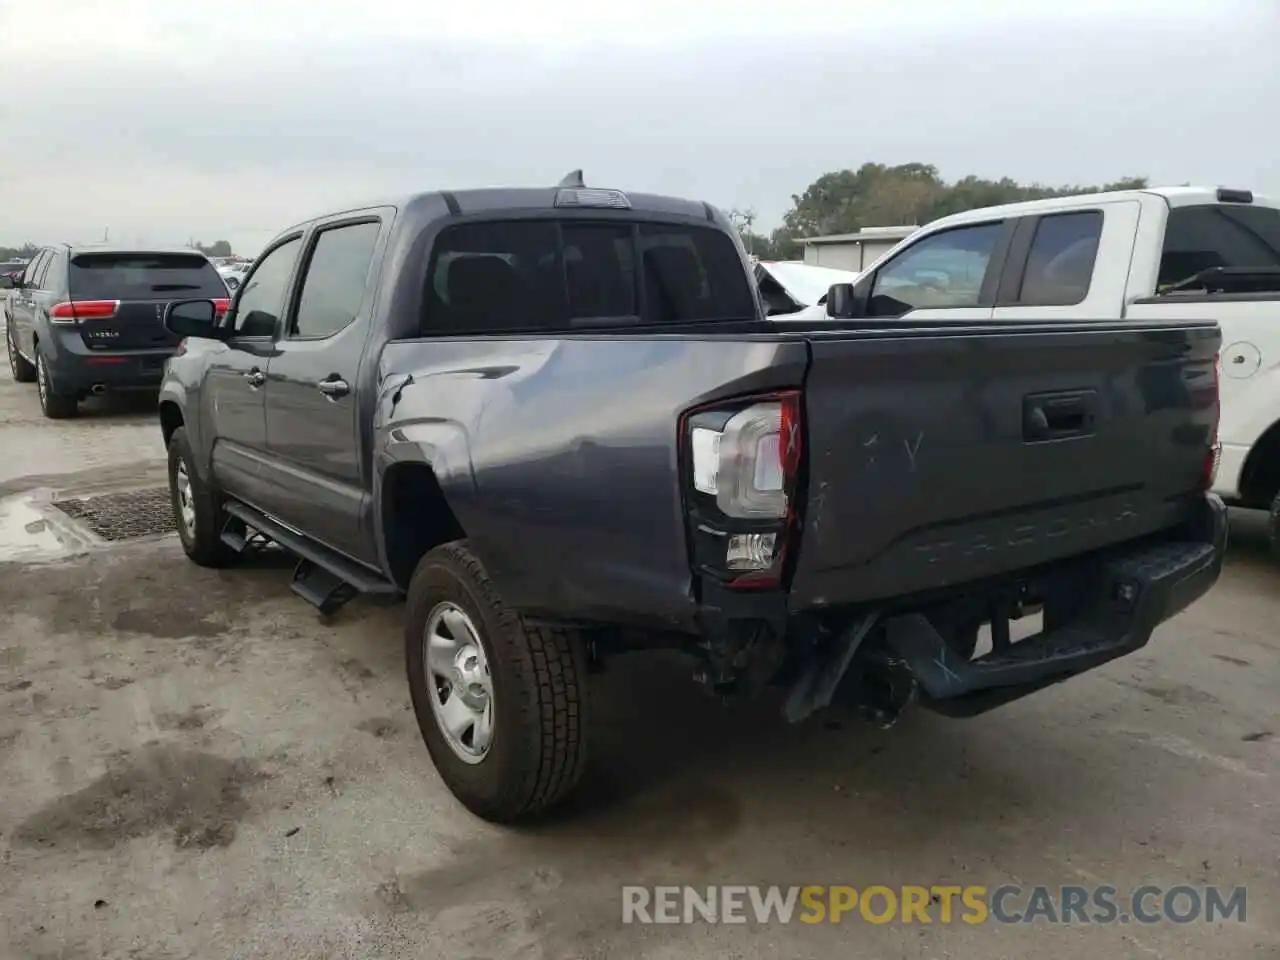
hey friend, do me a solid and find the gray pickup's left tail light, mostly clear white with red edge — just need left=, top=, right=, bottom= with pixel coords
left=681, top=390, right=804, bottom=588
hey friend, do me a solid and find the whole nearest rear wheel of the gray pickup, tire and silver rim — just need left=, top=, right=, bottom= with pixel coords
left=404, top=541, right=586, bottom=823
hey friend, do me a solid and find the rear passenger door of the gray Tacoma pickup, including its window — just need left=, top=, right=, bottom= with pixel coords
left=259, top=215, right=378, bottom=563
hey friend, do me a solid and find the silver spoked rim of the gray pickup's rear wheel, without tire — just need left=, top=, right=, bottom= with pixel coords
left=422, top=602, right=493, bottom=763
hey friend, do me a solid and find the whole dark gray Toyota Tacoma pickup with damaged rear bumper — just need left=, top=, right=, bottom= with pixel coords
left=160, top=174, right=1226, bottom=822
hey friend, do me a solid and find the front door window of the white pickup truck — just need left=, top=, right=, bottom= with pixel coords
left=868, top=221, right=1004, bottom=316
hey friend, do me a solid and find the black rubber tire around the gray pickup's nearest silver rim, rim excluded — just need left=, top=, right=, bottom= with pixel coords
left=404, top=540, right=586, bottom=823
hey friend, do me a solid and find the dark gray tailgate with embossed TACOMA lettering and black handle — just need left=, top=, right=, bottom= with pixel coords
left=791, top=321, right=1220, bottom=608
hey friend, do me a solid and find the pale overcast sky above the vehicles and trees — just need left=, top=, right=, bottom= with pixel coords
left=0, top=0, right=1280, bottom=253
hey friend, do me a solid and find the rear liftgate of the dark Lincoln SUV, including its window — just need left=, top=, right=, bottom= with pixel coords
left=68, top=251, right=227, bottom=360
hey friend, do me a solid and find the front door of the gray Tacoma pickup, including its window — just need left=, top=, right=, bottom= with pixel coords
left=205, top=237, right=302, bottom=509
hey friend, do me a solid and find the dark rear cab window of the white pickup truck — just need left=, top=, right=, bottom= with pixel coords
left=1157, top=204, right=1280, bottom=288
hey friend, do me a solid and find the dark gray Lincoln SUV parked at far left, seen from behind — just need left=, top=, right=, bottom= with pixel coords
left=6, top=243, right=228, bottom=419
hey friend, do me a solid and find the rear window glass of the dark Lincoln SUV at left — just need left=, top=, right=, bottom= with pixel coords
left=70, top=253, right=227, bottom=300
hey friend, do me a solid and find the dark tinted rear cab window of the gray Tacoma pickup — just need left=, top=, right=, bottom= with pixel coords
left=421, top=220, right=755, bottom=335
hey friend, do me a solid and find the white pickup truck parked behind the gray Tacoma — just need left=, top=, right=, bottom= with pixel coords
left=827, top=187, right=1280, bottom=557
